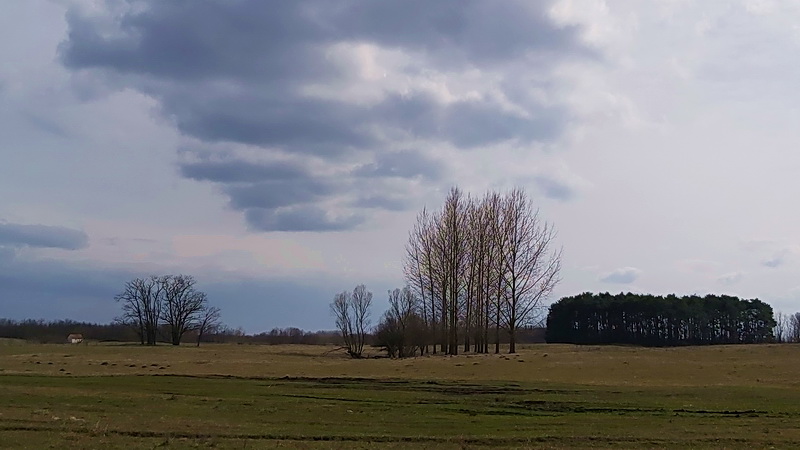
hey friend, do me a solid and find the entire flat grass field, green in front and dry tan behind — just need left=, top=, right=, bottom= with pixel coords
left=0, top=340, right=800, bottom=449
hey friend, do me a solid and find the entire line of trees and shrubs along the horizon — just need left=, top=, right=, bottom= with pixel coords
left=15, top=186, right=800, bottom=358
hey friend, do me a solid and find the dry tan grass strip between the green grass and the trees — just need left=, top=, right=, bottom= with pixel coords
left=0, top=343, right=800, bottom=387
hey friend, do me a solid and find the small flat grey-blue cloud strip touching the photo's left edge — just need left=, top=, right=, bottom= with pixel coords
left=0, top=222, right=89, bottom=250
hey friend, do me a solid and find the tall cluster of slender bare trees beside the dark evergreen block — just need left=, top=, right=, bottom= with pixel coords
left=400, top=187, right=561, bottom=355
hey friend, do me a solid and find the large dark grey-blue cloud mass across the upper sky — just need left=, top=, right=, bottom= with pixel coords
left=59, top=0, right=587, bottom=230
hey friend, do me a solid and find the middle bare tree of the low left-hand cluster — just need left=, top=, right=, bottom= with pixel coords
left=159, top=275, right=208, bottom=345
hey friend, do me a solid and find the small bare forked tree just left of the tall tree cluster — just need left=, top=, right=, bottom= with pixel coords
left=331, top=284, right=372, bottom=358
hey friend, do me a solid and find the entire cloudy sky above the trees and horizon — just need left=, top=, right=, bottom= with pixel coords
left=0, top=0, right=800, bottom=332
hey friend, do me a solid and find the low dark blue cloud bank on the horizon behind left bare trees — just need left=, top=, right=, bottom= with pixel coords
left=0, top=256, right=341, bottom=332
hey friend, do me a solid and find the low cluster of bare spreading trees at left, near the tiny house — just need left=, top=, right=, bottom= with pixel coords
left=115, top=275, right=220, bottom=346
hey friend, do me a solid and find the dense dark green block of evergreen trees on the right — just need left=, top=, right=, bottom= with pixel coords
left=546, top=293, right=775, bottom=346
